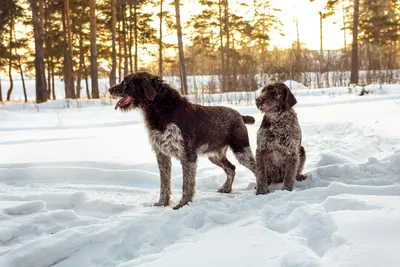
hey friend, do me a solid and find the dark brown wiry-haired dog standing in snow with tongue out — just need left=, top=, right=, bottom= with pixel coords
left=109, top=72, right=256, bottom=209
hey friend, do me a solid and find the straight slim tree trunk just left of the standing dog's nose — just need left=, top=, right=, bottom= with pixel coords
left=89, top=0, right=100, bottom=98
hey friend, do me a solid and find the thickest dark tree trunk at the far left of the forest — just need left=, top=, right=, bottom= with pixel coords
left=30, top=0, right=47, bottom=103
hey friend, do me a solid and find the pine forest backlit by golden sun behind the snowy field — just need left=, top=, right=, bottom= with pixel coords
left=0, top=0, right=400, bottom=103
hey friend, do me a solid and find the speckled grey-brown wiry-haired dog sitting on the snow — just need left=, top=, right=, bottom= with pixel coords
left=256, top=83, right=306, bottom=194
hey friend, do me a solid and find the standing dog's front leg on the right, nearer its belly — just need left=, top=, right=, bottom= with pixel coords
left=174, top=155, right=197, bottom=210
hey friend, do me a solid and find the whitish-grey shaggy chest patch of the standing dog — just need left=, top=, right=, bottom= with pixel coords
left=149, top=123, right=183, bottom=159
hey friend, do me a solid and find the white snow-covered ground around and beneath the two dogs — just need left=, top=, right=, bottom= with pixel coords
left=0, top=85, right=400, bottom=267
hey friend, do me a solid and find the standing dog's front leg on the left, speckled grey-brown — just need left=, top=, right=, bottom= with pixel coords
left=154, top=152, right=172, bottom=206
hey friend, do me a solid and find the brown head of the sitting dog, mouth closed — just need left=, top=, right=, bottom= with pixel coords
left=256, top=83, right=297, bottom=113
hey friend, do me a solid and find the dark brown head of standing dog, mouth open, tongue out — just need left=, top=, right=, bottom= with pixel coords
left=108, top=72, right=160, bottom=111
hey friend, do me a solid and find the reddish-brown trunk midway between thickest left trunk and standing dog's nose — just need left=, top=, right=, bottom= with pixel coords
left=64, top=0, right=75, bottom=98
